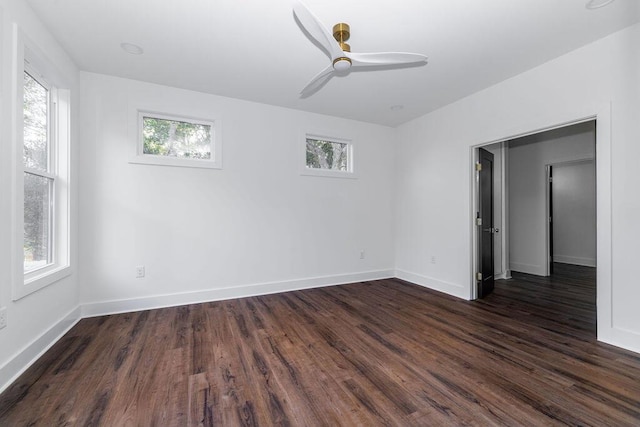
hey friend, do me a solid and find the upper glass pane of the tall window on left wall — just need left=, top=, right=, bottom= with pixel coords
left=23, top=72, right=49, bottom=171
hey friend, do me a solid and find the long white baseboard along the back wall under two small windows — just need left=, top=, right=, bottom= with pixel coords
left=82, top=269, right=394, bottom=317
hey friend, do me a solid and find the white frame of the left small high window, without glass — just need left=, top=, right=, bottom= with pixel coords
left=129, top=110, right=222, bottom=169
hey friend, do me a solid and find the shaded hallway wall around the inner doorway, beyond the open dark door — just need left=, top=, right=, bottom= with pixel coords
left=508, top=122, right=595, bottom=276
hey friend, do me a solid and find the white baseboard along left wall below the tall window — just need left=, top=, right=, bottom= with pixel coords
left=0, top=307, right=81, bottom=393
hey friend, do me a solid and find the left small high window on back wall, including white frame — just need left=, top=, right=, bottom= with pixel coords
left=132, top=112, right=221, bottom=168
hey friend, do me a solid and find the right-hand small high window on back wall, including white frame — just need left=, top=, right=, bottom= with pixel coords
left=302, top=134, right=355, bottom=178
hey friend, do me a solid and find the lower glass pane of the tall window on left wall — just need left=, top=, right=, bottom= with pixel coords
left=24, top=172, right=53, bottom=272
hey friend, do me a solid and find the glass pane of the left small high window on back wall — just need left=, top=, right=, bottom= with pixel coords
left=142, top=117, right=211, bottom=160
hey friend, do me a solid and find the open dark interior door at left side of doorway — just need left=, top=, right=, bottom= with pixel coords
left=477, top=148, right=495, bottom=298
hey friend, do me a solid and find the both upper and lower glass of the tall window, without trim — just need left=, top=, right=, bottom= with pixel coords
left=22, top=69, right=56, bottom=273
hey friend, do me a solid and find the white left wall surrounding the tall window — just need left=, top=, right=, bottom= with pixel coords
left=0, top=0, right=79, bottom=391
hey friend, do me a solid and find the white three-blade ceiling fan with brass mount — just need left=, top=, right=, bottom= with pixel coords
left=293, top=1, right=427, bottom=97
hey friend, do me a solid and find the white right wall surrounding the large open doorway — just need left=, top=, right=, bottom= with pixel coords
left=396, top=21, right=640, bottom=351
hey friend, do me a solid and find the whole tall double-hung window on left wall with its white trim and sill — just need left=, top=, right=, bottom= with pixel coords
left=13, top=42, right=71, bottom=300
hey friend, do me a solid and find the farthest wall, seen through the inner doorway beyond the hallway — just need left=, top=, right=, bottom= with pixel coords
left=552, top=161, right=596, bottom=267
